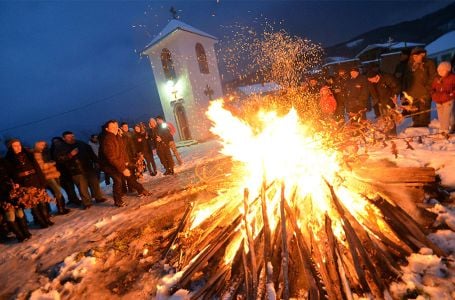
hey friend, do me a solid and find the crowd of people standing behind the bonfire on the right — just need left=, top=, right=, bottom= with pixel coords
left=306, top=47, right=455, bottom=133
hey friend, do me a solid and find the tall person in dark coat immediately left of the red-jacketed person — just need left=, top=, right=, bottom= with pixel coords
left=402, top=47, right=436, bottom=127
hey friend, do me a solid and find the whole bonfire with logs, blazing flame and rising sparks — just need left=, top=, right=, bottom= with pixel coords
left=157, top=28, right=445, bottom=299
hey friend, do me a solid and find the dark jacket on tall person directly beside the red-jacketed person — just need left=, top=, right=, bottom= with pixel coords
left=403, top=59, right=436, bottom=99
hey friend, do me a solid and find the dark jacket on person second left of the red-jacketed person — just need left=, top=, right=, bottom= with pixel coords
left=369, top=74, right=400, bottom=107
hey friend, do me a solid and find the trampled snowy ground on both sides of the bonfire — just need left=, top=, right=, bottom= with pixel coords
left=0, top=123, right=455, bottom=299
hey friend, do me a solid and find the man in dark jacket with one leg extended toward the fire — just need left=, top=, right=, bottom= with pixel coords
left=99, top=120, right=150, bottom=207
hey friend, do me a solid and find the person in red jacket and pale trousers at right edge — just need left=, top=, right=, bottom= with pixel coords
left=431, top=61, right=455, bottom=133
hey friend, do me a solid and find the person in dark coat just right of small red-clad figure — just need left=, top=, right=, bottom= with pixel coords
left=346, top=68, right=369, bottom=120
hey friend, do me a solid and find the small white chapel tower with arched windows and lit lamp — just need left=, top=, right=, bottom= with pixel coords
left=142, top=19, right=223, bottom=141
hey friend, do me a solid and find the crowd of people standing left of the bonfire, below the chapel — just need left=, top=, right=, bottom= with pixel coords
left=0, top=116, right=183, bottom=242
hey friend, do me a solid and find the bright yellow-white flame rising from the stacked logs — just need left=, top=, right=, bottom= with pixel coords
left=192, top=100, right=400, bottom=263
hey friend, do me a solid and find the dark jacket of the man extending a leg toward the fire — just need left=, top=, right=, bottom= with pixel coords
left=99, top=132, right=129, bottom=173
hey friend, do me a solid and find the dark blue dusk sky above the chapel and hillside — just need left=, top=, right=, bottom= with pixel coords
left=0, top=0, right=451, bottom=151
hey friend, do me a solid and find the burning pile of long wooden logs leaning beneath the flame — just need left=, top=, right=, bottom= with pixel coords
left=158, top=167, right=445, bottom=299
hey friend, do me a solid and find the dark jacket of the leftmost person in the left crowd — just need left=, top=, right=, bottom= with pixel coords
left=5, top=148, right=46, bottom=188
